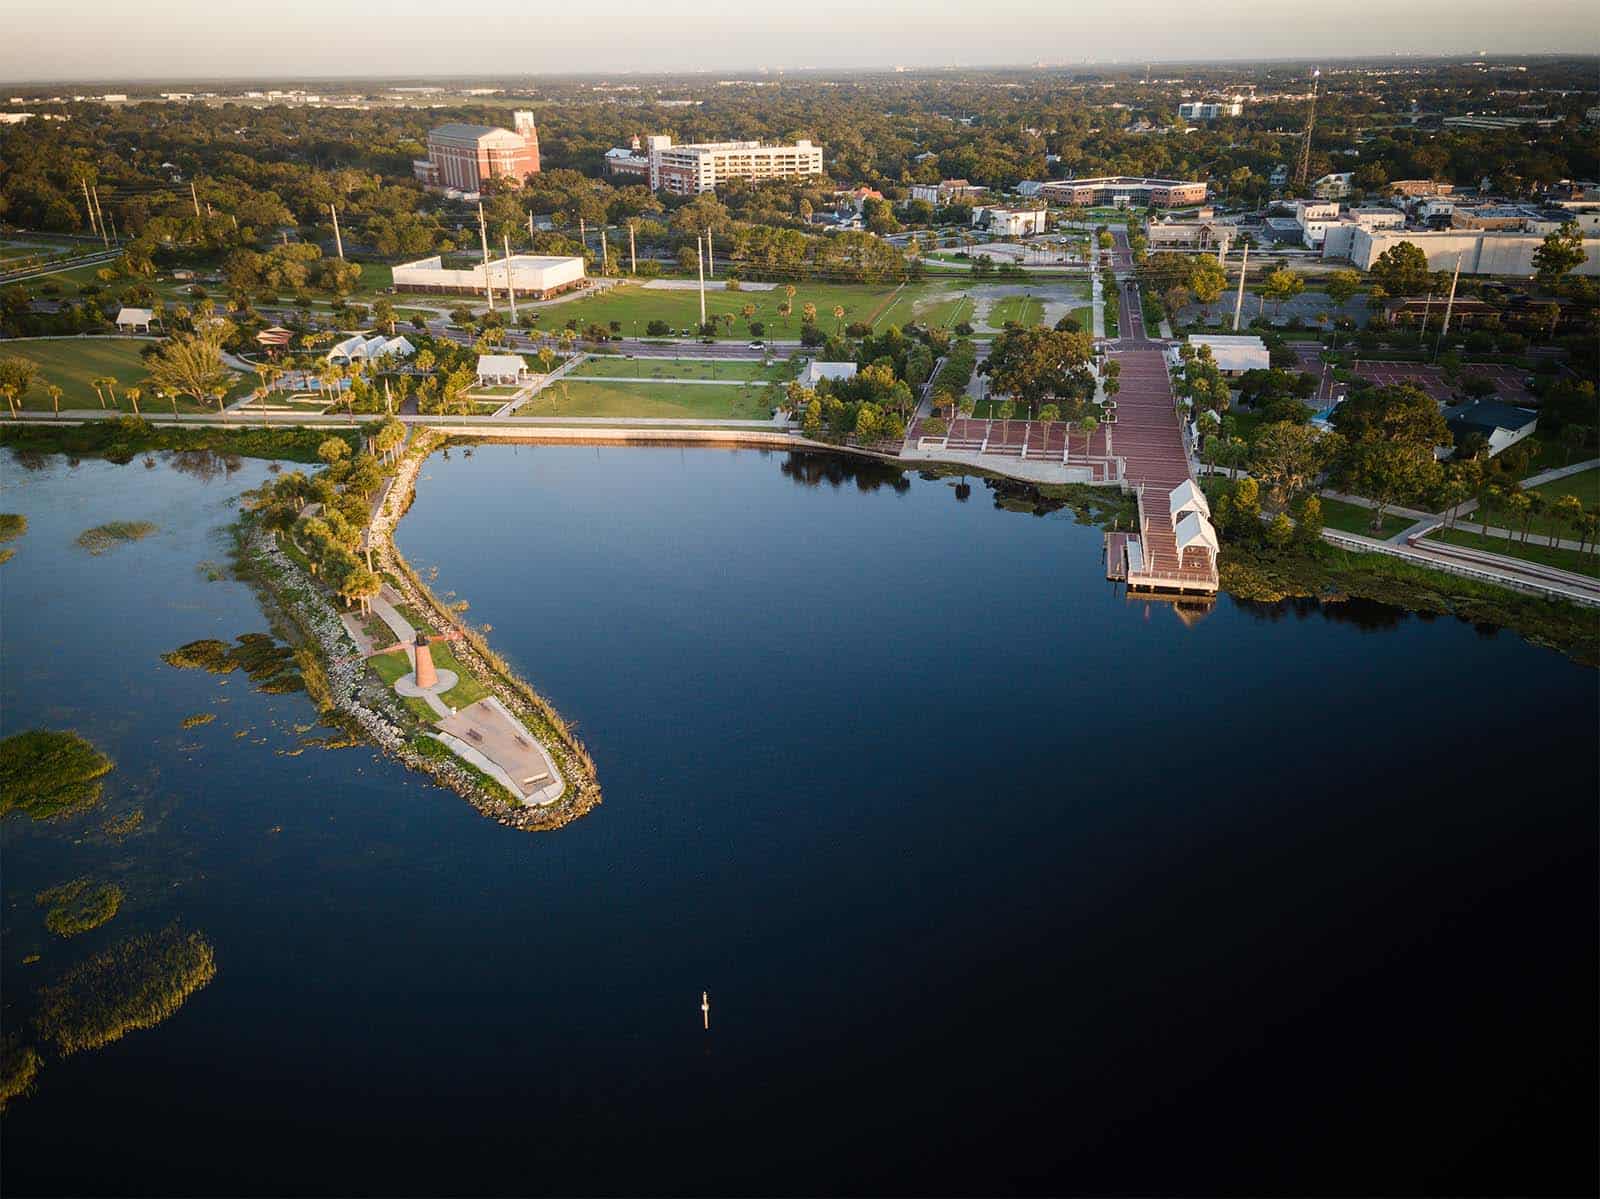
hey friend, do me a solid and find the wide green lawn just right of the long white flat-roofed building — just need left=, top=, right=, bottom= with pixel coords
left=539, top=283, right=917, bottom=341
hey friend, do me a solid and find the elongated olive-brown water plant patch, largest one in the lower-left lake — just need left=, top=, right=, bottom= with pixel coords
left=37, top=927, right=216, bottom=1055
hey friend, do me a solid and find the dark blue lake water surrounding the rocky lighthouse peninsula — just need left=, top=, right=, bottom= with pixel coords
left=0, top=447, right=1600, bottom=1194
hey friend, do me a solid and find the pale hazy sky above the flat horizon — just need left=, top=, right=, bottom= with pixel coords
left=0, top=0, right=1600, bottom=83
